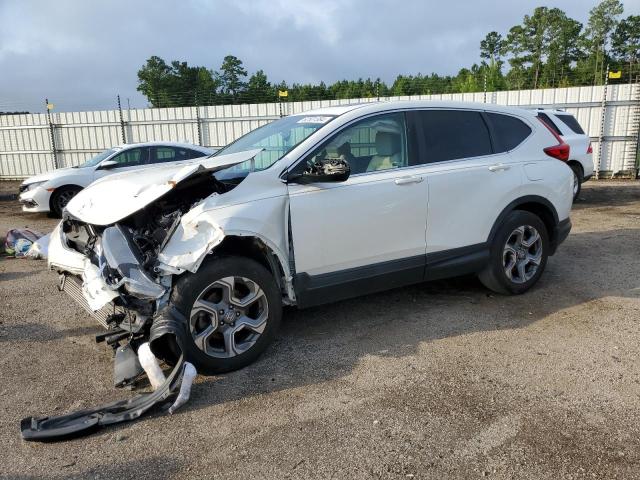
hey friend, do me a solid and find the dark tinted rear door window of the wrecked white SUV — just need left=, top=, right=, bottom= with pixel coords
left=420, top=110, right=493, bottom=163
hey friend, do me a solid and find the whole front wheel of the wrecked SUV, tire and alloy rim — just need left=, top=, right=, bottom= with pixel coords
left=171, top=257, right=282, bottom=374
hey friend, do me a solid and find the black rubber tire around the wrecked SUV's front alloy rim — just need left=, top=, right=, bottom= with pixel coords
left=171, top=256, right=282, bottom=375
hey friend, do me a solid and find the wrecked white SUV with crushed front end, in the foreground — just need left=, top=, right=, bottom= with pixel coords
left=49, top=102, right=573, bottom=373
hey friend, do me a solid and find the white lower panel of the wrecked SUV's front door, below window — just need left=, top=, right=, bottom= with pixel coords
left=289, top=167, right=428, bottom=275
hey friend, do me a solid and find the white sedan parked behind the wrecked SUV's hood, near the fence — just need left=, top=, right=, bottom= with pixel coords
left=18, top=142, right=213, bottom=216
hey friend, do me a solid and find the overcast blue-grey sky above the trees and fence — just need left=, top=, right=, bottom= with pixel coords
left=0, top=0, right=640, bottom=111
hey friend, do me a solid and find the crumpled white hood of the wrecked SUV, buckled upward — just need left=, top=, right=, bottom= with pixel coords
left=67, top=148, right=262, bottom=225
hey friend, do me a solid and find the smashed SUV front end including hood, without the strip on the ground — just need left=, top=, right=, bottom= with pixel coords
left=48, top=150, right=260, bottom=386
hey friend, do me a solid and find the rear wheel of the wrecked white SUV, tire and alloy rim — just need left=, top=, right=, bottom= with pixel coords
left=478, top=210, right=549, bottom=295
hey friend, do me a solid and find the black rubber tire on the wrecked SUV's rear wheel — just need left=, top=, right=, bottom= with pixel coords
left=478, top=210, right=549, bottom=295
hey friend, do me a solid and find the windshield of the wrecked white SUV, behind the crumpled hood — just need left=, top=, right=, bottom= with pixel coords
left=215, top=115, right=335, bottom=177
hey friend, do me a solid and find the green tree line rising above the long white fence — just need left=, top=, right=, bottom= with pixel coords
left=138, top=0, right=640, bottom=107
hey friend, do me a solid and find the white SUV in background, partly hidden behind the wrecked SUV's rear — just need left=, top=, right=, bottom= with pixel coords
left=537, top=108, right=593, bottom=201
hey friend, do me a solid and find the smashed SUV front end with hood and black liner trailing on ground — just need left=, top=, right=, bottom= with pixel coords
left=21, top=150, right=260, bottom=440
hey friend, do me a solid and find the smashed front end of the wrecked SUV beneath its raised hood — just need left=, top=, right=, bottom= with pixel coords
left=49, top=159, right=235, bottom=344
